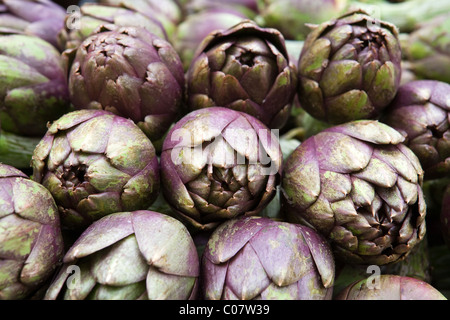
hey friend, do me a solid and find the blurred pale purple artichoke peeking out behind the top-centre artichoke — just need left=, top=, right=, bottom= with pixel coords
left=173, top=9, right=247, bottom=71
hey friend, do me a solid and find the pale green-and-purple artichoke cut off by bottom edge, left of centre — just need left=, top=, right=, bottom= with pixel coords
left=44, top=211, right=200, bottom=300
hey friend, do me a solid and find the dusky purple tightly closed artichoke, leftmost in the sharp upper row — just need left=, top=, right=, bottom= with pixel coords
left=69, top=26, right=185, bottom=141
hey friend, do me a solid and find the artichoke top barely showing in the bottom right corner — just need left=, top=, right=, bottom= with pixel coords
left=335, top=275, right=447, bottom=300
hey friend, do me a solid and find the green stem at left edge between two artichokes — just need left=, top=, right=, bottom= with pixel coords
left=0, top=131, right=41, bottom=169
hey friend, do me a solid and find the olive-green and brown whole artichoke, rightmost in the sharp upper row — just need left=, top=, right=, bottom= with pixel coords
left=298, top=11, right=402, bottom=124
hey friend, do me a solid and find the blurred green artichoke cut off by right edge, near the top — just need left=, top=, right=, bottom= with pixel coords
left=402, top=13, right=450, bottom=83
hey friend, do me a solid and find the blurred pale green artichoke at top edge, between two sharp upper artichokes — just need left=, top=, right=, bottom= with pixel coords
left=257, top=0, right=349, bottom=40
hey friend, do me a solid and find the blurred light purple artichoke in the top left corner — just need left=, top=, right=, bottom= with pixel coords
left=0, top=0, right=66, bottom=50
